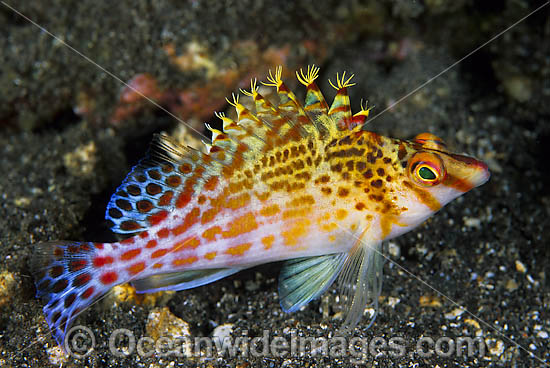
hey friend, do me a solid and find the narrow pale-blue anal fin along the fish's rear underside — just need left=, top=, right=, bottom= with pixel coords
left=132, top=268, right=242, bottom=293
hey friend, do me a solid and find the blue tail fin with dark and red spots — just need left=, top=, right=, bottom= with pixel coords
left=31, top=241, right=112, bottom=346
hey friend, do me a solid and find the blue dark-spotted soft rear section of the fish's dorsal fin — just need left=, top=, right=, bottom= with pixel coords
left=105, top=135, right=224, bottom=234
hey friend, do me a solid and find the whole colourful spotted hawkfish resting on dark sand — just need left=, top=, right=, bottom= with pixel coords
left=31, top=65, right=490, bottom=346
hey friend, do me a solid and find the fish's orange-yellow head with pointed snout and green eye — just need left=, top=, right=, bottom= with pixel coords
left=355, top=132, right=490, bottom=239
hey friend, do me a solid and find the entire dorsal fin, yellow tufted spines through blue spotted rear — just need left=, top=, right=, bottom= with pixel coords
left=106, top=65, right=376, bottom=234
